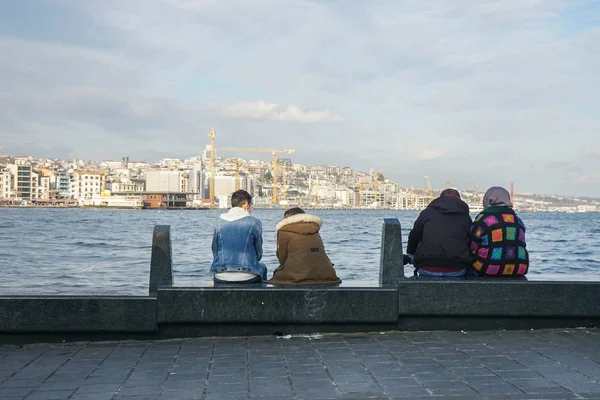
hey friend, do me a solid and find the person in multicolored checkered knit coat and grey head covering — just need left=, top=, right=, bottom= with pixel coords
left=469, top=186, right=529, bottom=276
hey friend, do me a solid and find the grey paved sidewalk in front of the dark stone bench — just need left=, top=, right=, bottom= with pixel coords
left=0, top=329, right=600, bottom=400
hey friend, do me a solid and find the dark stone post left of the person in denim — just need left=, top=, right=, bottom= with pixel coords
left=148, top=225, right=173, bottom=296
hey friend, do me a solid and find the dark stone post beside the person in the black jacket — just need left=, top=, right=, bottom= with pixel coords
left=379, top=218, right=404, bottom=285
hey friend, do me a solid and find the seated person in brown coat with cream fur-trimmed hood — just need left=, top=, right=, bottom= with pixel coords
left=266, top=208, right=341, bottom=285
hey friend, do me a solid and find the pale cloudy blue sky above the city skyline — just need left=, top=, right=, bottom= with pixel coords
left=0, top=0, right=600, bottom=197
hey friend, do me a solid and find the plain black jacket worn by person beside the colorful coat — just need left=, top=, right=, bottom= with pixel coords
left=406, top=197, right=472, bottom=269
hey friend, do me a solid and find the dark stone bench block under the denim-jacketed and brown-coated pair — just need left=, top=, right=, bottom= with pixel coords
left=157, top=287, right=398, bottom=324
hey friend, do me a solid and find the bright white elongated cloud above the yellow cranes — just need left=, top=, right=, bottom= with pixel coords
left=221, top=101, right=342, bottom=123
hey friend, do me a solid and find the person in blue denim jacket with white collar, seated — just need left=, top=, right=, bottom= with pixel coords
left=210, top=190, right=267, bottom=283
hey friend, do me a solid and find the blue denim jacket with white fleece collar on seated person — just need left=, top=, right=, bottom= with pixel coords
left=210, top=207, right=264, bottom=276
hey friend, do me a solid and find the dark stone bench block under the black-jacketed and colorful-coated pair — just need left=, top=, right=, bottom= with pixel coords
left=398, top=278, right=600, bottom=318
